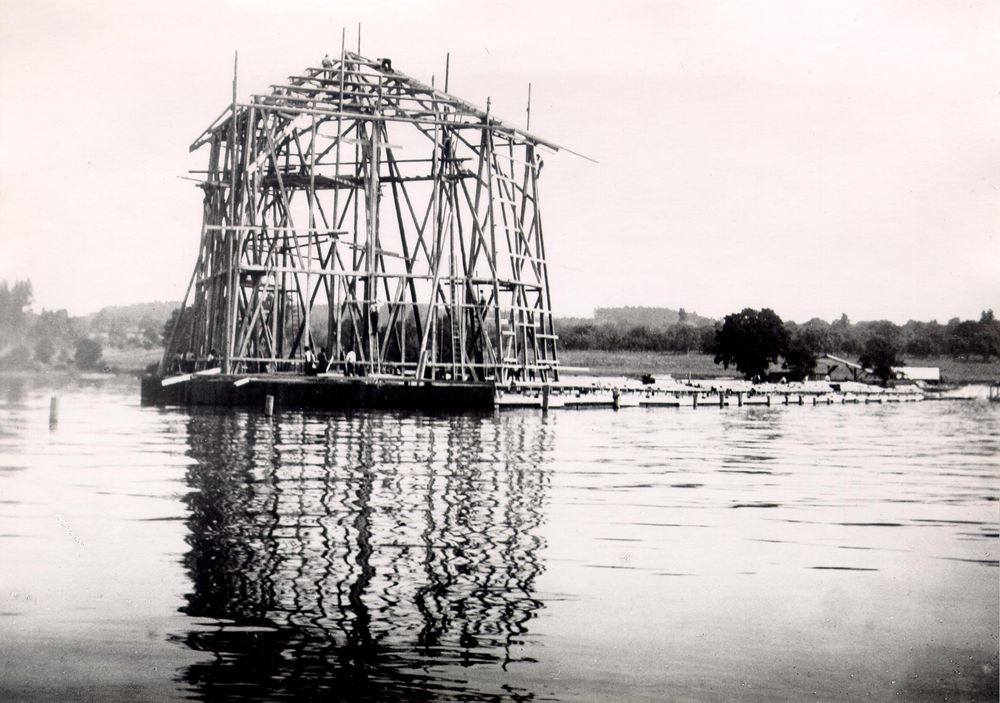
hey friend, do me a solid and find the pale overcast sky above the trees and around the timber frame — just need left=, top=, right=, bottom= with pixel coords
left=0, top=0, right=1000, bottom=322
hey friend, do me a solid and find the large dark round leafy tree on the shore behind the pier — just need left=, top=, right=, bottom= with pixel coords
left=715, top=308, right=788, bottom=378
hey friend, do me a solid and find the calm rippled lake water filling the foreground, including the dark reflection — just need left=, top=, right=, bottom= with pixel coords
left=0, top=381, right=1000, bottom=701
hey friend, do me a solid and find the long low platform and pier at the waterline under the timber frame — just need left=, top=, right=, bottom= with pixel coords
left=142, top=369, right=944, bottom=412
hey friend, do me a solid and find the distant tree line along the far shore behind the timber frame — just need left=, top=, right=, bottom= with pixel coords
left=0, top=280, right=1000, bottom=376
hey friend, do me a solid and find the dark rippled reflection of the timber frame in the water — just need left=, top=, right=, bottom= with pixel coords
left=176, top=414, right=549, bottom=700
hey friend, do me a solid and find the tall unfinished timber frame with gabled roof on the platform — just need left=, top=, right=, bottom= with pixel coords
left=161, top=51, right=572, bottom=382
